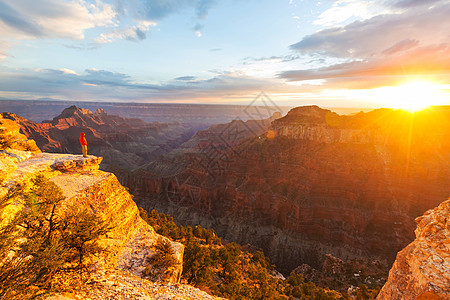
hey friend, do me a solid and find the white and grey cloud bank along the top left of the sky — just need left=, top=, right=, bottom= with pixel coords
left=0, top=0, right=215, bottom=52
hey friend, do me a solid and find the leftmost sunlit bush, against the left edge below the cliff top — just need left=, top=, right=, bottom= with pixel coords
left=0, top=176, right=65, bottom=299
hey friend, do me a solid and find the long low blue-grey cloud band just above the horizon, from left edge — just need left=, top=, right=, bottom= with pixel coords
left=0, top=68, right=318, bottom=103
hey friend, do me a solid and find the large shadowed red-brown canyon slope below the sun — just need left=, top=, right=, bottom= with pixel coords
left=118, top=106, right=450, bottom=272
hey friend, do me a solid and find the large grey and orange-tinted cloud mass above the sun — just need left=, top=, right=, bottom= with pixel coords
left=279, top=0, right=450, bottom=88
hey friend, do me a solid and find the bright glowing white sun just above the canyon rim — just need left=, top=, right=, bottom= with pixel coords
left=383, top=80, right=449, bottom=112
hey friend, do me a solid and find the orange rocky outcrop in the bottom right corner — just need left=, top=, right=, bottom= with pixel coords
left=377, top=200, right=450, bottom=300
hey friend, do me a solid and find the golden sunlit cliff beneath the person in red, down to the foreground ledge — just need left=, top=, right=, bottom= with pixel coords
left=0, top=115, right=222, bottom=299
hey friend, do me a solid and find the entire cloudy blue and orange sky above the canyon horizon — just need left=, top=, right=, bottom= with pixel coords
left=0, top=0, right=450, bottom=108
